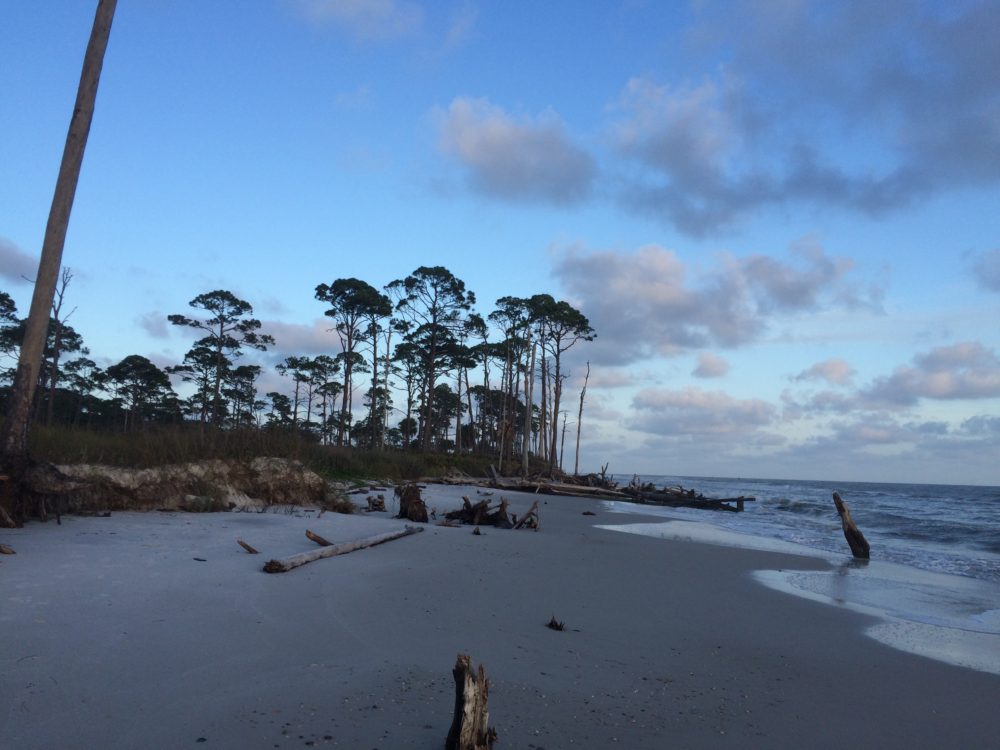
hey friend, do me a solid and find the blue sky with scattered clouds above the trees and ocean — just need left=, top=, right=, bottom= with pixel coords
left=0, top=0, right=1000, bottom=485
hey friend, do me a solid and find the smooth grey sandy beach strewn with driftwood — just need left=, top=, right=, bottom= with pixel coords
left=0, top=486, right=1000, bottom=750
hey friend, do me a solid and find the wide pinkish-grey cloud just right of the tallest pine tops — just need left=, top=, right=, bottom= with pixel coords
left=553, top=239, right=876, bottom=364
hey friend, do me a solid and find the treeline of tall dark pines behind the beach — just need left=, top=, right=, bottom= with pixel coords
left=0, top=266, right=595, bottom=470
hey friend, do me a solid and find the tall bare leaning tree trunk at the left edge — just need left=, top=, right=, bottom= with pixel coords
left=0, top=0, right=117, bottom=525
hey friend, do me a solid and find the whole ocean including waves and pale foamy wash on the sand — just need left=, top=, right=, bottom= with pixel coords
left=604, top=475, right=1000, bottom=674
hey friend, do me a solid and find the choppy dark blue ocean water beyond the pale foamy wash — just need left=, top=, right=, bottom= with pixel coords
left=617, top=475, right=1000, bottom=582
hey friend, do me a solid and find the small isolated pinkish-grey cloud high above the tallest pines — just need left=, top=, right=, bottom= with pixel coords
left=437, top=97, right=594, bottom=209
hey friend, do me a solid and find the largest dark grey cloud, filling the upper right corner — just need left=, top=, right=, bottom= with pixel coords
left=614, top=0, right=1000, bottom=235
